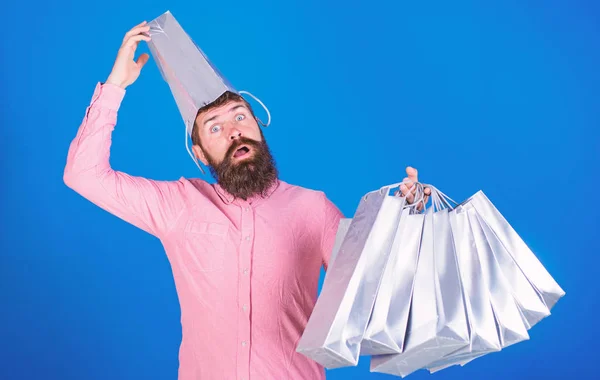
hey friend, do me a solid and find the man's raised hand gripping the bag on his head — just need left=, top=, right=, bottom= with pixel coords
left=106, top=21, right=150, bottom=88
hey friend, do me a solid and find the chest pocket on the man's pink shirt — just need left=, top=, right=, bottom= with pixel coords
left=183, top=220, right=228, bottom=272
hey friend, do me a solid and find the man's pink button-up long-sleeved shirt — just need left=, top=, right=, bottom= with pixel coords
left=64, top=83, right=343, bottom=380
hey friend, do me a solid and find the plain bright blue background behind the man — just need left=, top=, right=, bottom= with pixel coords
left=0, top=0, right=600, bottom=380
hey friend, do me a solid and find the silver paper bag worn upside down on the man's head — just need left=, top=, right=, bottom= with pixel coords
left=148, top=11, right=271, bottom=173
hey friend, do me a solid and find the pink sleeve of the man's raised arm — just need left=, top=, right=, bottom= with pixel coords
left=63, top=83, right=184, bottom=238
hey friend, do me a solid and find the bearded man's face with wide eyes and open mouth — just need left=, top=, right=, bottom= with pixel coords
left=192, top=101, right=277, bottom=199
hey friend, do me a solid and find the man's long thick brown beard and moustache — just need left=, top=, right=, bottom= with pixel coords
left=207, top=137, right=278, bottom=200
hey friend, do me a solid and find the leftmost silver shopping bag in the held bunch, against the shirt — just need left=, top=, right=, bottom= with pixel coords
left=296, top=185, right=405, bottom=368
